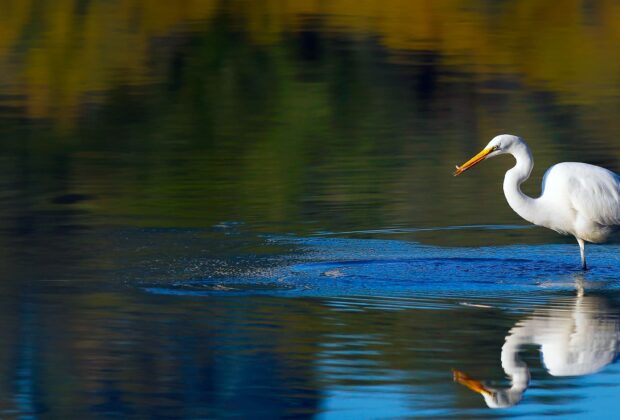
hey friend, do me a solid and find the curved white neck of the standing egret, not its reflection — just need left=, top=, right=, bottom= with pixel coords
left=504, top=144, right=540, bottom=224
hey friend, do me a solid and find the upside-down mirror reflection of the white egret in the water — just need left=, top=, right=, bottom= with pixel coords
left=454, top=278, right=620, bottom=408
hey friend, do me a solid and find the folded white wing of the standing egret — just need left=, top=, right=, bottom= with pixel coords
left=564, top=163, right=620, bottom=226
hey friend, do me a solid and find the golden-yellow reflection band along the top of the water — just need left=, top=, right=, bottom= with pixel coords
left=0, top=0, right=620, bottom=123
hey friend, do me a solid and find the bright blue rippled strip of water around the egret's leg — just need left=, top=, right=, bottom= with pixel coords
left=145, top=226, right=620, bottom=297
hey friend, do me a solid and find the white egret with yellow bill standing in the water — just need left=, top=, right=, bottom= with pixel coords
left=454, top=134, right=620, bottom=270
